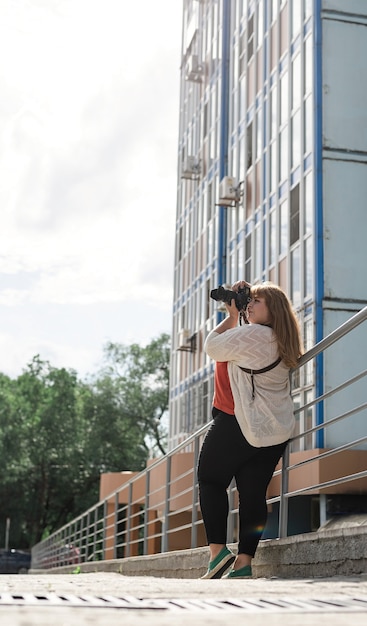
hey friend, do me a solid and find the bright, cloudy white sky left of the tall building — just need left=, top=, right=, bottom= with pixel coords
left=0, top=0, right=182, bottom=378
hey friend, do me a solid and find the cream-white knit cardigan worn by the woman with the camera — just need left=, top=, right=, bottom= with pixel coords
left=204, top=324, right=295, bottom=448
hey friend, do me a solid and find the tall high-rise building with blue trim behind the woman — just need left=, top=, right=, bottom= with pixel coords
left=170, top=0, right=367, bottom=528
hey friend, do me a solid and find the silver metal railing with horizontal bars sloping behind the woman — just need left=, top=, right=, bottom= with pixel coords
left=32, top=307, right=367, bottom=569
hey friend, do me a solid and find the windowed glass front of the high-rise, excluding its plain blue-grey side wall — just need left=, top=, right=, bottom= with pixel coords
left=170, top=0, right=315, bottom=447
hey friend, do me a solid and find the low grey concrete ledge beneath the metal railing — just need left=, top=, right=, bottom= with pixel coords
left=30, top=518, right=367, bottom=579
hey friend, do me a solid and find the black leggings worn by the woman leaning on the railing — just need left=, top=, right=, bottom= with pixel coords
left=198, top=409, right=287, bottom=556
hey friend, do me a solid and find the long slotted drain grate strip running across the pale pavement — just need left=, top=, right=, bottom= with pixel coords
left=0, top=593, right=367, bottom=613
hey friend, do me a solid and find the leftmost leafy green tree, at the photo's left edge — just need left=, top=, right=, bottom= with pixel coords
left=2, top=356, right=82, bottom=545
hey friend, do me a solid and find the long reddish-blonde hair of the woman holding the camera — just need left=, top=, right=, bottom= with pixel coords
left=251, top=282, right=303, bottom=367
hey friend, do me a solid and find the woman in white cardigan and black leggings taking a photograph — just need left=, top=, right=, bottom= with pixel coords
left=198, top=281, right=303, bottom=578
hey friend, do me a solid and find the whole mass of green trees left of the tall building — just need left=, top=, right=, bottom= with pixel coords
left=0, top=335, right=170, bottom=548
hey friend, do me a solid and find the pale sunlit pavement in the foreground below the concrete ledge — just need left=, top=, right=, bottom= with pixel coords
left=0, top=571, right=367, bottom=626
